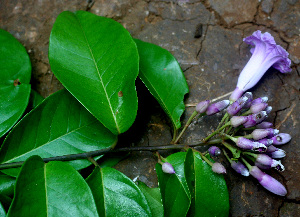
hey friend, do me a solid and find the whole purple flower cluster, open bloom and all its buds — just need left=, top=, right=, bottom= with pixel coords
left=161, top=31, right=291, bottom=196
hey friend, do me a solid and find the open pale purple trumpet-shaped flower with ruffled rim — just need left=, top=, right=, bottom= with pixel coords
left=230, top=30, right=291, bottom=101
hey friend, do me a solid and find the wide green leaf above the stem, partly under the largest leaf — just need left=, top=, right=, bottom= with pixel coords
left=0, top=89, right=117, bottom=176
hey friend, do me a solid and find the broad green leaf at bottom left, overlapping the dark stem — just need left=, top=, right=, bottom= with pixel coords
left=8, top=156, right=98, bottom=217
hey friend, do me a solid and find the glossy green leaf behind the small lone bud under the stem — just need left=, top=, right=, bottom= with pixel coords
left=155, top=152, right=191, bottom=217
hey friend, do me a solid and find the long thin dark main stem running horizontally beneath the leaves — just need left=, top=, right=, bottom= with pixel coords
left=0, top=139, right=222, bottom=170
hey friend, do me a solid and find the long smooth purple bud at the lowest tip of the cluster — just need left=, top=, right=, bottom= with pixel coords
left=250, top=166, right=287, bottom=196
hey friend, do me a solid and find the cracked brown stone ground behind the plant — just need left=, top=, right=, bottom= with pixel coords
left=0, top=0, right=300, bottom=217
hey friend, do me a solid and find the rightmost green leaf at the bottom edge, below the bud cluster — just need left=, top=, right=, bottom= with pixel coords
left=185, top=149, right=229, bottom=217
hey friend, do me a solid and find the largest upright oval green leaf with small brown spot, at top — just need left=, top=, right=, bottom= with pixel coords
left=49, top=11, right=139, bottom=134
